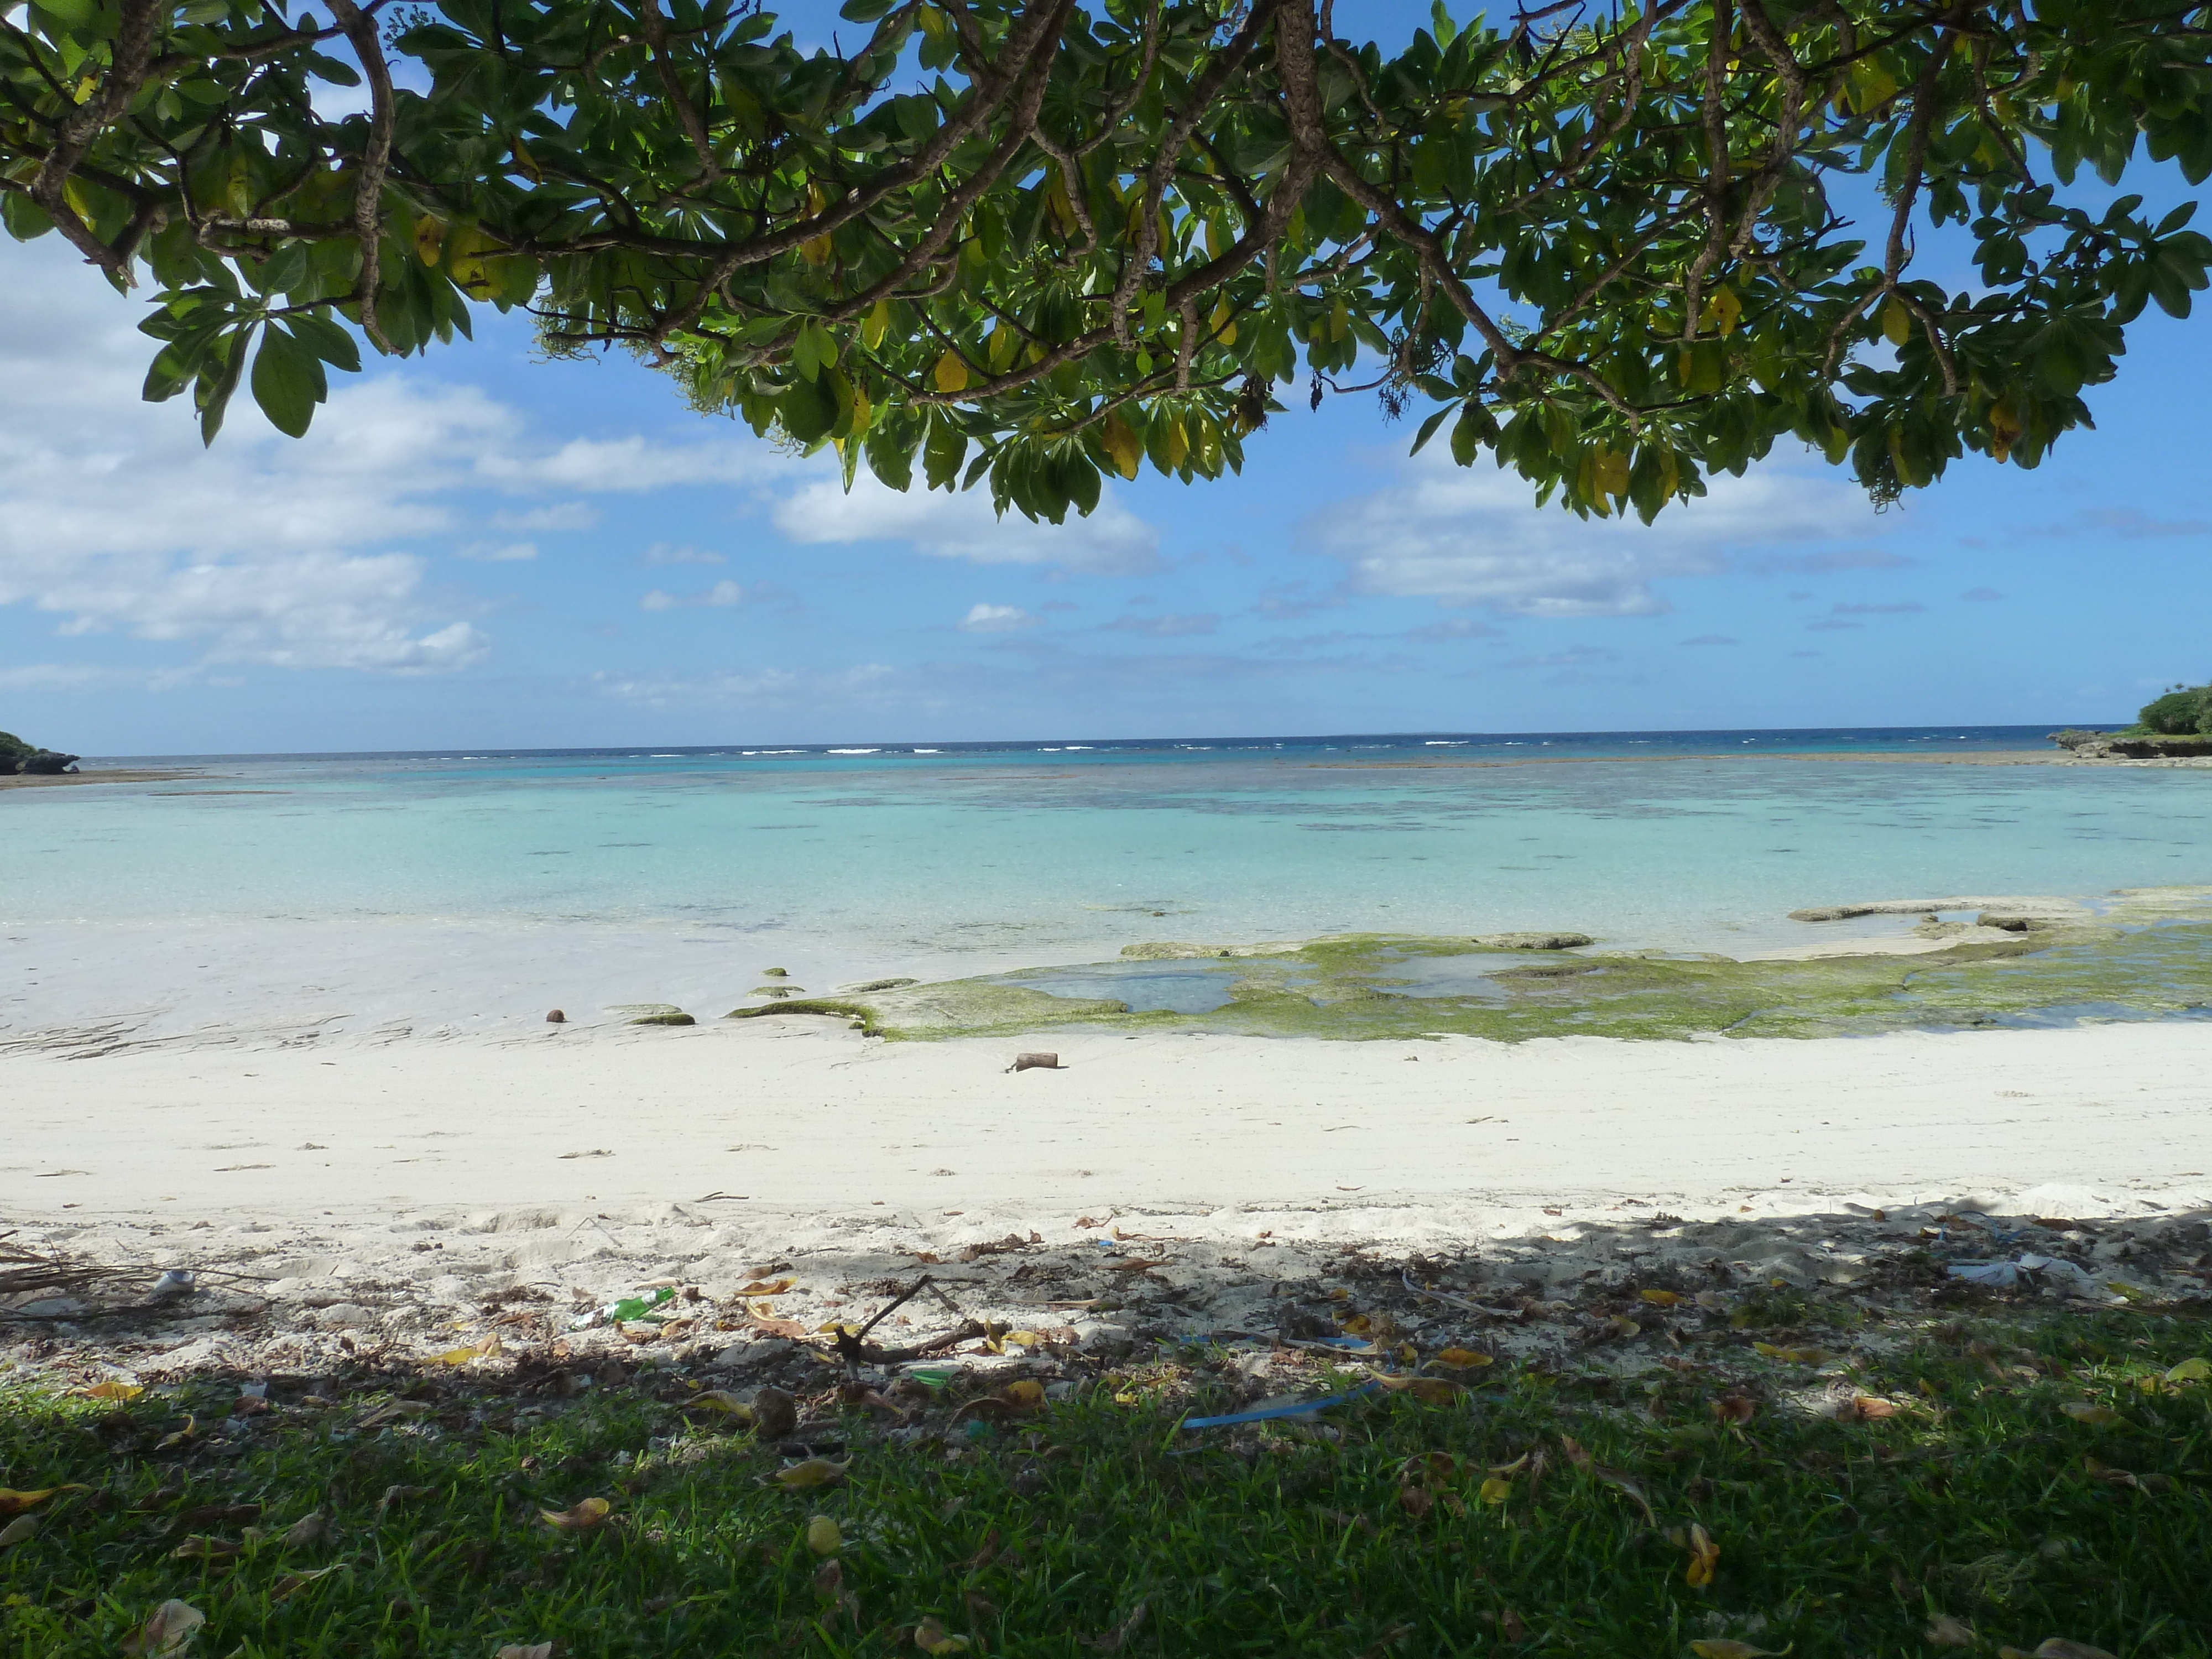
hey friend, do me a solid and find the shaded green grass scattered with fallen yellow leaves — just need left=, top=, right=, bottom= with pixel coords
left=0, top=1310, right=2212, bottom=1659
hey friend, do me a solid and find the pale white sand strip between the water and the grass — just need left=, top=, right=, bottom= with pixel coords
left=0, top=1018, right=2212, bottom=1398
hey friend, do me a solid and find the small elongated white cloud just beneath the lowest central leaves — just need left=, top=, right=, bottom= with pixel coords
left=770, top=476, right=1159, bottom=575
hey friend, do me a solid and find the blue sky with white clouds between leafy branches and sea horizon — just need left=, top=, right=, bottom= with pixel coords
left=0, top=30, right=2212, bottom=754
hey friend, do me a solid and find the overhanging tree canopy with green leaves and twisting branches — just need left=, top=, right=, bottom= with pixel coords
left=0, top=0, right=2212, bottom=522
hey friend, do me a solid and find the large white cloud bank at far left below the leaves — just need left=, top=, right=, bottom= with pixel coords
left=0, top=237, right=770, bottom=686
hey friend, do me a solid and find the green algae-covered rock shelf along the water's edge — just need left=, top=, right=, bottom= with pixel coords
left=730, top=916, right=2212, bottom=1042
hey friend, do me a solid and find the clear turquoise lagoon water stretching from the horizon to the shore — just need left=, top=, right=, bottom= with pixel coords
left=0, top=728, right=2212, bottom=1026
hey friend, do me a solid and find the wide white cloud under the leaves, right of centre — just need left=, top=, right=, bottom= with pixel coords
left=1307, top=449, right=1887, bottom=617
